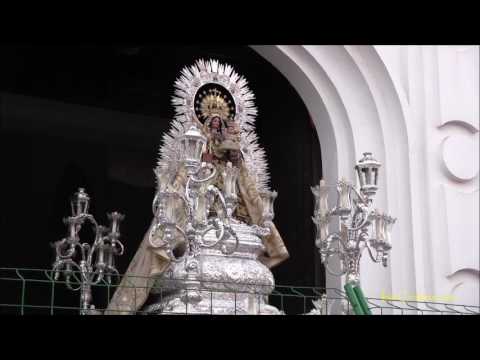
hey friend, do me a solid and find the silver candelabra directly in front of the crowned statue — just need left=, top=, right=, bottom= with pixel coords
left=149, top=122, right=273, bottom=304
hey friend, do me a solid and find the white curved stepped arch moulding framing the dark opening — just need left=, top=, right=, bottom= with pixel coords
left=253, top=46, right=418, bottom=296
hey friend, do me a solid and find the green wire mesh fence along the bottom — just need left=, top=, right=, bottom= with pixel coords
left=0, top=268, right=480, bottom=315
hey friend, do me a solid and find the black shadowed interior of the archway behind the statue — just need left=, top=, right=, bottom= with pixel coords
left=0, top=43, right=325, bottom=313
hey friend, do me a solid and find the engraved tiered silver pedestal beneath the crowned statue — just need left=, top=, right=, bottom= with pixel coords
left=143, top=222, right=281, bottom=315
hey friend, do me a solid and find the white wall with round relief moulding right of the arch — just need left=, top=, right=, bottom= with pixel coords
left=376, top=46, right=480, bottom=305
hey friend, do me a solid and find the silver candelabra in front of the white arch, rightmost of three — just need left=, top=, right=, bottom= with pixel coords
left=311, top=152, right=396, bottom=285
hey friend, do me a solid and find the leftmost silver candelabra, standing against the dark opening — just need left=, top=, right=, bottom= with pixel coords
left=53, top=188, right=124, bottom=315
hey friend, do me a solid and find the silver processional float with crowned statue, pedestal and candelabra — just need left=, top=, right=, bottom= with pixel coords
left=53, top=60, right=395, bottom=315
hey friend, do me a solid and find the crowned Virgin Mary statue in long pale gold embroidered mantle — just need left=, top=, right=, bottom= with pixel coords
left=105, top=60, right=289, bottom=315
